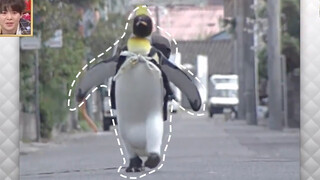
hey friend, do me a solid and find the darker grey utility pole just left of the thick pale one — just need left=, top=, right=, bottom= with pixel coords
left=243, top=0, right=258, bottom=125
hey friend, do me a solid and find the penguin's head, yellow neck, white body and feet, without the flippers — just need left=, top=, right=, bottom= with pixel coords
left=114, top=9, right=164, bottom=172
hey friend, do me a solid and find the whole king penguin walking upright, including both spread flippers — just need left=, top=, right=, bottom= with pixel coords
left=77, top=5, right=201, bottom=172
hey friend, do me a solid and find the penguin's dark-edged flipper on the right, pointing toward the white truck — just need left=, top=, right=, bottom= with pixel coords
left=160, top=57, right=201, bottom=111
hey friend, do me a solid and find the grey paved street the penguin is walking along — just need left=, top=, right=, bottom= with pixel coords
left=20, top=112, right=300, bottom=180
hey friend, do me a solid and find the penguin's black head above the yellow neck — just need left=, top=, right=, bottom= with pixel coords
left=133, top=14, right=152, bottom=38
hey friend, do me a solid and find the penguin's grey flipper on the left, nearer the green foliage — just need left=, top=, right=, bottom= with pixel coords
left=76, top=56, right=119, bottom=102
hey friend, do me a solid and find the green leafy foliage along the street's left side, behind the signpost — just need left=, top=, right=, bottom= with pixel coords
left=20, top=0, right=131, bottom=138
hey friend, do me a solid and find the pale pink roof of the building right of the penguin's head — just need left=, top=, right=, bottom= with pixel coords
left=150, top=5, right=224, bottom=41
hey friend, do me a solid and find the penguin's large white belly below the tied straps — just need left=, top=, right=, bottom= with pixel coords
left=115, top=62, right=163, bottom=156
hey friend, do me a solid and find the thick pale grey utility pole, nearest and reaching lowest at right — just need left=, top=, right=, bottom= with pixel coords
left=267, top=0, right=283, bottom=130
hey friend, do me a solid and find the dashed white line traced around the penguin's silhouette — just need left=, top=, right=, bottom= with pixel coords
left=68, top=5, right=209, bottom=179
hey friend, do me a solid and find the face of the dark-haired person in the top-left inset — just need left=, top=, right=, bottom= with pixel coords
left=0, top=8, right=22, bottom=34
